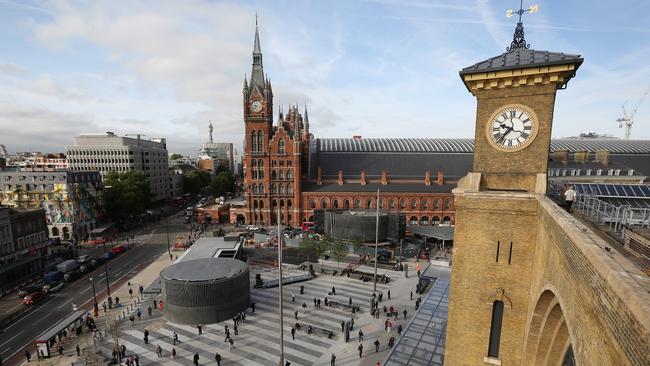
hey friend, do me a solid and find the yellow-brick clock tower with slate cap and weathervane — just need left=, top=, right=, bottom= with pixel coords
left=445, top=16, right=583, bottom=365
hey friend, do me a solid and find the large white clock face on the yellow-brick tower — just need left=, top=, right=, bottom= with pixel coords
left=486, top=105, right=538, bottom=151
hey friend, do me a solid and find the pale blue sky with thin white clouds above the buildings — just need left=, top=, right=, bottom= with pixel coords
left=0, top=0, right=650, bottom=155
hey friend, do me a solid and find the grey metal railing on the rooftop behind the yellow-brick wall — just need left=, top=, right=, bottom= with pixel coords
left=548, top=183, right=650, bottom=232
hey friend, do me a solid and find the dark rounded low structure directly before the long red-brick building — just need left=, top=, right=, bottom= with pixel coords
left=325, top=210, right=389, bottom=242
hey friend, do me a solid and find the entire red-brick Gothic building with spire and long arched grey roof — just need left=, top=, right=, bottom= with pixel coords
left=239, top=23, right=458, bottom=226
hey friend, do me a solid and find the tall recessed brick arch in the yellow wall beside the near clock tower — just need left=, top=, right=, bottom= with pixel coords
left=524, top=289, right=573, bottom=366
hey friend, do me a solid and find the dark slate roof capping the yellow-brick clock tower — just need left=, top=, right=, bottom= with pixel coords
left=460, top=48, right=584, bottom=76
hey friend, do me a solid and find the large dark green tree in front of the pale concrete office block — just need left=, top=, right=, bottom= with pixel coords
left=104, top=170, right=151, bottom=221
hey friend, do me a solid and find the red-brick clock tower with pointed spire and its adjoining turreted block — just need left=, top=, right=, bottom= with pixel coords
left=242, top=21, right=310, bottom=226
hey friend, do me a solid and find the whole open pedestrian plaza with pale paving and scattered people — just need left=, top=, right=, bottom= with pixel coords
left=93, top=264, right=426, bottom=366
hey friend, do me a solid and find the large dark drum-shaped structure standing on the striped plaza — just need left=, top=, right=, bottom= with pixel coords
left=160, top=258, right=250, bottom=325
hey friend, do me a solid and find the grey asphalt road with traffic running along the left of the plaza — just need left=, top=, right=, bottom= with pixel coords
left=0, top=216, right=187, bottom=363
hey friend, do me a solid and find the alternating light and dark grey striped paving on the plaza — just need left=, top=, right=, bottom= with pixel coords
left=102, top=275, right=388, bottom=366
